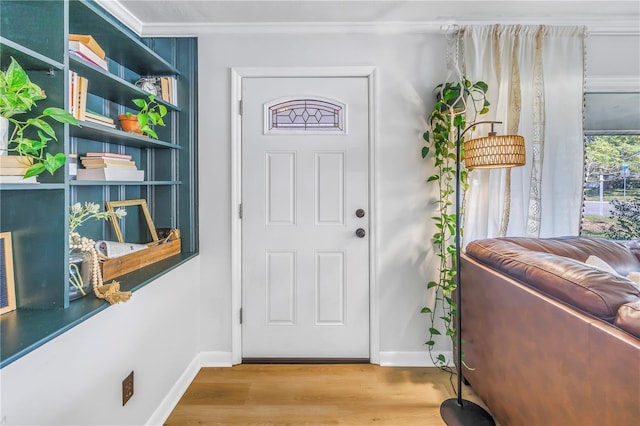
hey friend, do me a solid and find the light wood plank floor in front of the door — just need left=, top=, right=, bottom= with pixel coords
left=165, top=364, right=496, bottom=426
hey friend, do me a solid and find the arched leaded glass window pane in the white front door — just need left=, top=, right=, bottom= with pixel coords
left=268, top=99, right=344, bottom=132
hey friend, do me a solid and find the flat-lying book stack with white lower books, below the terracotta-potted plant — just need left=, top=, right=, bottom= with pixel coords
left=77, top=152, right=144, bottom=181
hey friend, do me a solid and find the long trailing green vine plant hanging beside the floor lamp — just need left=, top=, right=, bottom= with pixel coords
left=421, top=77, right=489, bottom=370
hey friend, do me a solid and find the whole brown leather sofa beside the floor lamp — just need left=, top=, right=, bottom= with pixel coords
left=461, top=237, right=640, bottom=426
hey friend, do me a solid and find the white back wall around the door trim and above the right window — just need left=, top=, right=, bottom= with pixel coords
left=199, top=29, right=640, bottom=365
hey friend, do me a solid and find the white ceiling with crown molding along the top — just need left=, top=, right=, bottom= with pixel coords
left=98, top=0, right=640, bottom=34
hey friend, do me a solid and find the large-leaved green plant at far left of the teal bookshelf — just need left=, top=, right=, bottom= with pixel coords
left=0, top=57, right=78, bottom=178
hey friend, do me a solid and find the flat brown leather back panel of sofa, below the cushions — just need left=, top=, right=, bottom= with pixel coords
left=460, top=255, right=640, bottom=426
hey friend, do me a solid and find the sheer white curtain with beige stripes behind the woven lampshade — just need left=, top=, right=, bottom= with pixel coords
left=460, top=25, right=585, bottom=242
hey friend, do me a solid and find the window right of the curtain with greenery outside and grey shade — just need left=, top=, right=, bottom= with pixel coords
left=580, top=92, right=640, bottom=239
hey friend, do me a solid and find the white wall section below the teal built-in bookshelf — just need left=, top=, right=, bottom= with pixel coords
left=0, top=257, right=200, bottom=426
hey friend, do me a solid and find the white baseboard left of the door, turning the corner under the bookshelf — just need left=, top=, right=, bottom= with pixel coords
left=146, top=351, right=233, bottom=426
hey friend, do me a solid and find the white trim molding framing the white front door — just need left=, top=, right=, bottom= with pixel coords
left=230, top=66, right=380, bottom=364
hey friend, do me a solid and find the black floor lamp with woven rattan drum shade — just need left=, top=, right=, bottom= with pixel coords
left=440, top=121, right=525, bottom=426
